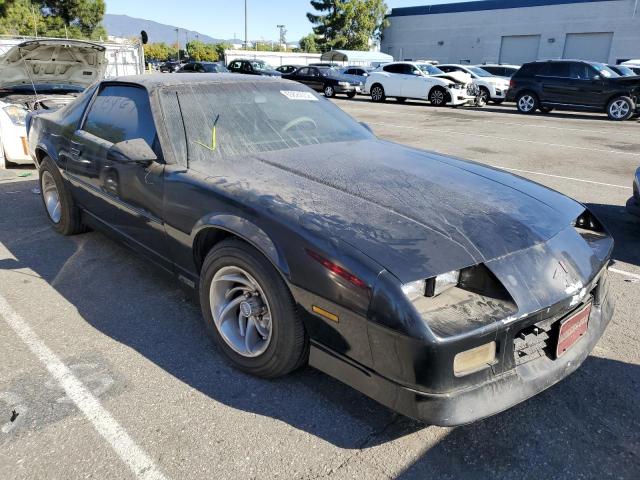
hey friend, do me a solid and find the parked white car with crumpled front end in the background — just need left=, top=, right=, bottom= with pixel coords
left=364, top=62, right=477, bottom=106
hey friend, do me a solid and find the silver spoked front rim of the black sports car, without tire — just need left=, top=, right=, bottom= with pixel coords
left=209, top=266, right=272, bottom=358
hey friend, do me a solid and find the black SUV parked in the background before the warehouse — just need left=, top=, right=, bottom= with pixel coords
left=507, top=60, right=640, bottom=120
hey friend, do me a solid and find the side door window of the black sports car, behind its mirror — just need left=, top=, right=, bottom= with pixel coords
left=82, top=85, right=156, bottom=146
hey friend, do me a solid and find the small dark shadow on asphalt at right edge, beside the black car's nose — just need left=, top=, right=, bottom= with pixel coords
left=587, top=202, right=640, bottom=266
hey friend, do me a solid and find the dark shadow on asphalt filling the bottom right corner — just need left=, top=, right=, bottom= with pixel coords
left=396, top=356, right=640, bottom=480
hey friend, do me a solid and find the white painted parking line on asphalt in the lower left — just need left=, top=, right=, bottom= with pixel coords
left=0, top=295, right=166, bottom=480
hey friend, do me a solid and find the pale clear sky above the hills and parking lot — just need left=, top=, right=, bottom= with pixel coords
left=106, top=0, right=476, bottom=41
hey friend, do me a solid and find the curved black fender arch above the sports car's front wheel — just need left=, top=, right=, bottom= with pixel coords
left=191, top=213, right=289, bottom=278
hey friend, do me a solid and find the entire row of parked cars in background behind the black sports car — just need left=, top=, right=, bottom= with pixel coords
left=170, top=59, right=640, bottom=121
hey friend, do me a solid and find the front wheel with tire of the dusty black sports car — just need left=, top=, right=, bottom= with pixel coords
left=200, top=238, right=308, bottom=378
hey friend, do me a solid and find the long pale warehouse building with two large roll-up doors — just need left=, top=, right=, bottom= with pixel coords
left=381, top=0, right=640, bottom=65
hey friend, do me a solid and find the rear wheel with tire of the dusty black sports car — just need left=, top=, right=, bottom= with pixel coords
left=39, top=157, right=85, bottom=235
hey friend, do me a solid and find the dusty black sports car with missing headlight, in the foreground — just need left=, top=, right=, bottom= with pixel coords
left=28, top=74, right=613, bottom=425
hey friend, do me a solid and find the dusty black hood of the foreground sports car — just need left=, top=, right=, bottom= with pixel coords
left=204, top=140, right=584, bottom=282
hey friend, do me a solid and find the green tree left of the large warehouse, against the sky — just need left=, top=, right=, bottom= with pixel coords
left=307, top=0, right=388, bottom=51
